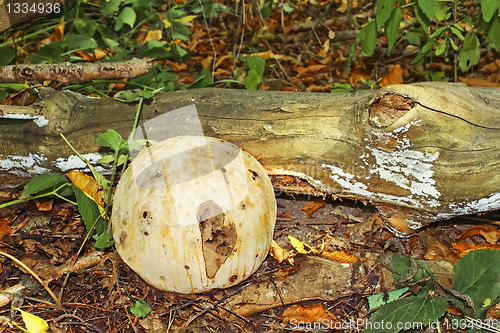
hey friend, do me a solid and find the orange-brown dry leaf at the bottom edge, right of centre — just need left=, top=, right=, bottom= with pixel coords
left=281, top=303, right=340, bottom=329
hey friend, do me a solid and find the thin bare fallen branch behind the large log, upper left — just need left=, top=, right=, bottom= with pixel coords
left=0, top=59, right=153, bottom=83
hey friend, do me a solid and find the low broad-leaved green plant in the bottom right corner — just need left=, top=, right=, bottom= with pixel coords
left=364, top=250, right=500, bottom=333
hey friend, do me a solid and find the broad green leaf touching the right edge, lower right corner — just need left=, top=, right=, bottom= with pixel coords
left=453, top=250, right=500, bottom=318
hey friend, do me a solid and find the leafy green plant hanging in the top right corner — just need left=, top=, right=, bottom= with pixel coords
left=352, top=0, right=500, bottom=75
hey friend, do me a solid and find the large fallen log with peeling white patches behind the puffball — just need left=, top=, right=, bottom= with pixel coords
left=0, top=83, right=500, bottom=234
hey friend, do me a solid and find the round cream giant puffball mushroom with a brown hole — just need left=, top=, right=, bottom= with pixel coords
left=111, top=136, right=276, bottom=293
